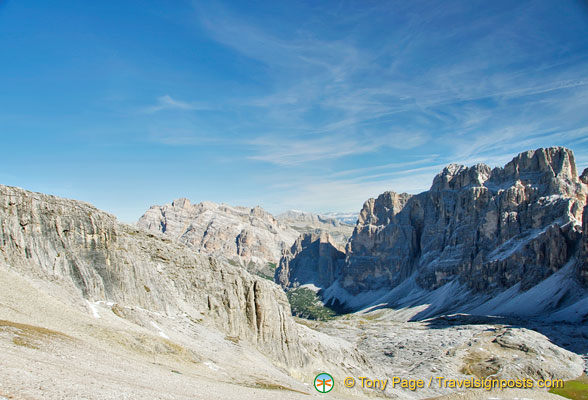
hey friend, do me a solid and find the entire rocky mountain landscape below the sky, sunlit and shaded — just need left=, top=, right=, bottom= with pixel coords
left=0, top=147, right=588, bottom=399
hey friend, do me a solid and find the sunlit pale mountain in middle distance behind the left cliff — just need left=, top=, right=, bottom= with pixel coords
left=137, top=199, right=298, bottom=276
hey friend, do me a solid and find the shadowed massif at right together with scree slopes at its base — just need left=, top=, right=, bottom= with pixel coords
left=282, top=147, right=588, bottom=318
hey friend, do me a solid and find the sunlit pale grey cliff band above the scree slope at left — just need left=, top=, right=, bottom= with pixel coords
left=0, top=186, right=307, bottom=366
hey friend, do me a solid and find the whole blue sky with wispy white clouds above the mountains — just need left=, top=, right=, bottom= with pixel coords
left=0, top=0, right=588, bottom=222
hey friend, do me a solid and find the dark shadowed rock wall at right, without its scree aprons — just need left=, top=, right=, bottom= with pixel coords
left=341, top=147, right=588, bottom=293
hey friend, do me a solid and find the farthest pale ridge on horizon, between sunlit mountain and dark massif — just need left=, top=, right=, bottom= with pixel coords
left=276, top=210, right=355, bottom=245
